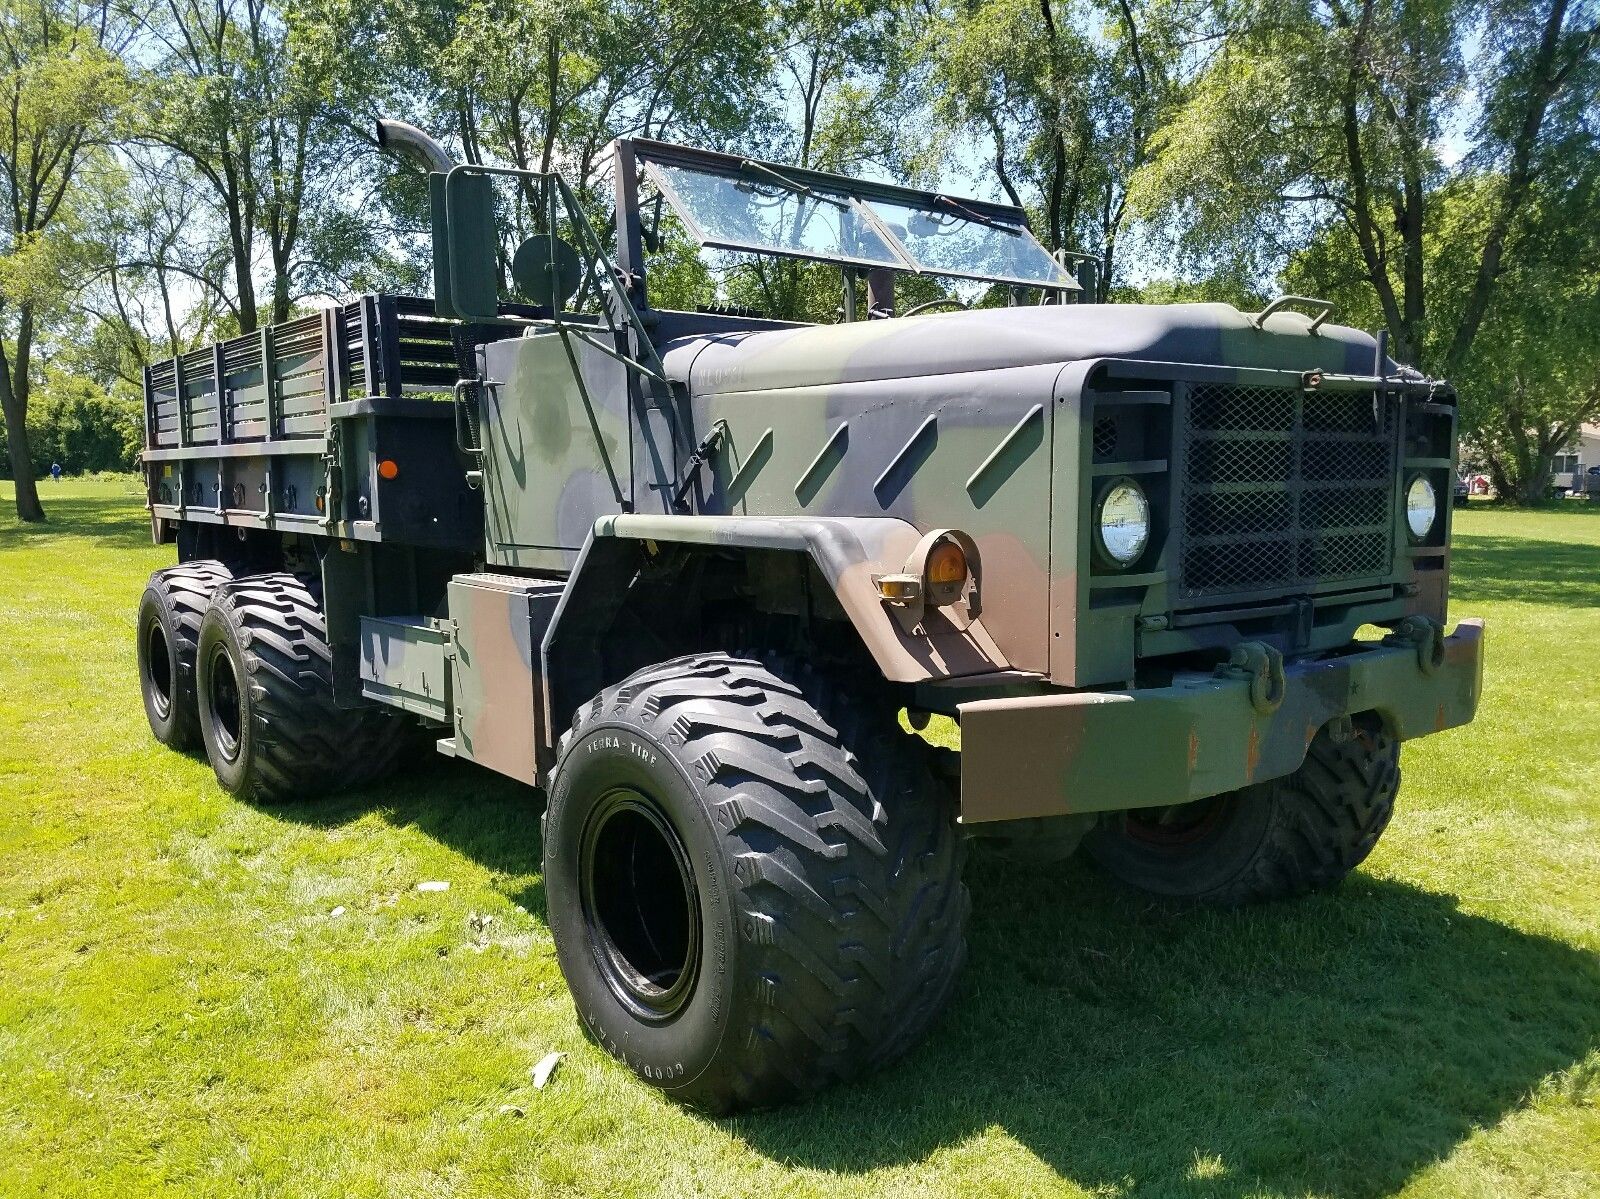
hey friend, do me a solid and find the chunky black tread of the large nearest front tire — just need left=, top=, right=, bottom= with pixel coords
left=558, top=653, right=970, bottom=1111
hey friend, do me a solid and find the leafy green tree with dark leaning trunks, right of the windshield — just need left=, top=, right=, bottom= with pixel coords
left=1131, top=0, right=1600, bottom=498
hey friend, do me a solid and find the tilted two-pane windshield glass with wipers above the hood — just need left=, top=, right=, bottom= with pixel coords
left=642, top=146, right=1077, bottom=290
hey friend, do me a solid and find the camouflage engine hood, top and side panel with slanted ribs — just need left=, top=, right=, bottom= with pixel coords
left=635, top=304, right=1443, bottom=687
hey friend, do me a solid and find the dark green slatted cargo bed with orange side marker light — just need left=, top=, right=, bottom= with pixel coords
left=144, top=295, right=546, bottom=549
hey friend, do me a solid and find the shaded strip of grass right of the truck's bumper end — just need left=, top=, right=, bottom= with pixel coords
left=1450, top=533, right=1600, bottom=615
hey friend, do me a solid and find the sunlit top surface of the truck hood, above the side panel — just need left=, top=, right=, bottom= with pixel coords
left=662, top=304, right=1397, bottom=395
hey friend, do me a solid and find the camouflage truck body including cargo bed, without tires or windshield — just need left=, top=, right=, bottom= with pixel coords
left=146, top=135, right=1482, bottom=820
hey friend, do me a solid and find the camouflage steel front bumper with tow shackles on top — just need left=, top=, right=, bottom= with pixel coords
left=960, top=620, right=1483, bottom=823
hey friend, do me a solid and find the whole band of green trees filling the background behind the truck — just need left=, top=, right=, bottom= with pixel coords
left=0, top=0, right=1600, bottom=509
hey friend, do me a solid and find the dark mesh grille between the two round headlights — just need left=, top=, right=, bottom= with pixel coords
left=1179, top=384, right=1398, bottom=599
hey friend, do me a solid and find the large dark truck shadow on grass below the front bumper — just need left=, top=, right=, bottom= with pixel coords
left=728, top=855, right=1600, bottom=1199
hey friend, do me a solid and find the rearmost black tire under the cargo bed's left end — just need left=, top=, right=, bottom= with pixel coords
left=138, top=560, right=234, bottom=751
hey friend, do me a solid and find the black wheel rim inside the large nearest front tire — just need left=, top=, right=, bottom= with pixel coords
left=579, top=788, right=701, bottom=1021
